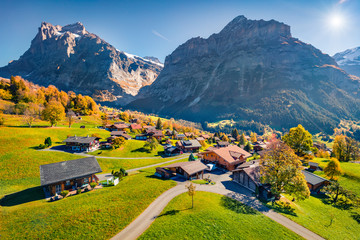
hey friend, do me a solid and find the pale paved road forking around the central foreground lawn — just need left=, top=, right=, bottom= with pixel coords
left=112, top=173, right=323, bottom=240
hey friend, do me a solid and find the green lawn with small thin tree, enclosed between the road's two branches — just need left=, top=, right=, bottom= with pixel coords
left=139, top=192, right=302, bottom=239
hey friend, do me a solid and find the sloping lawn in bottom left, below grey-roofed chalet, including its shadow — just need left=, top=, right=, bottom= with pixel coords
left=0, top=168, right=176, bottom=239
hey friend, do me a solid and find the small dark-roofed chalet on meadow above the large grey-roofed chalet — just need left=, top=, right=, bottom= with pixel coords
left=63, top=135, right=100, bottom=152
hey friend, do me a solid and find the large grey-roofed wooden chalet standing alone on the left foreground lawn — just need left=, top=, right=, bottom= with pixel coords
left=40, top=157, right=102, bottom=196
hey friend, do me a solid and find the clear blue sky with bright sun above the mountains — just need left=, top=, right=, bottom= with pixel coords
left=0, top=0, right=360, bottom=66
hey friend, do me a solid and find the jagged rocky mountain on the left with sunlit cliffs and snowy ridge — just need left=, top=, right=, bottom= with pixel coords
left=0, top=22, right=163, bottom=103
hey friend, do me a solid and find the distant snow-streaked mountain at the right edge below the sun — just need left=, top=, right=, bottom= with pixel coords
left=333, top=47, right=360, bottom=77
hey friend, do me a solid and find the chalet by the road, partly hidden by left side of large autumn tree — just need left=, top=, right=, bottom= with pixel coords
left=232, top=161, right=272, bottom=201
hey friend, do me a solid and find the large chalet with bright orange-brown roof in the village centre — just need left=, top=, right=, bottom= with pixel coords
left=198, top=145, right=251, bottom=171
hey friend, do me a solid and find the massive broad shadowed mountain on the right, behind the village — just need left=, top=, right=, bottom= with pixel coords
left=128, top=16, right=360, bottom=132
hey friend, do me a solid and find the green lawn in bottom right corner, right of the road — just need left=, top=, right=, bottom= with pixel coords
left=268, top=196, right=360, bottom=240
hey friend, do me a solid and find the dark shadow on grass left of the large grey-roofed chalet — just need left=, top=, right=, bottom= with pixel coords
left=0, top=186, right=44, bottom=207
